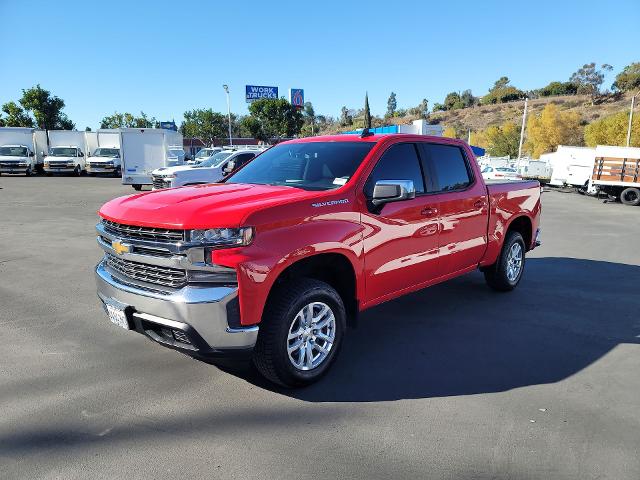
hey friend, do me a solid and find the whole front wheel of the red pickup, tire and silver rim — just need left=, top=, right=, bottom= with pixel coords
left=253, top=279, right=346, bottom=387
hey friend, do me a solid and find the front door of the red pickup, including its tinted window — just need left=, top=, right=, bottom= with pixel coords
left=362, top=143, right=440, bottom=302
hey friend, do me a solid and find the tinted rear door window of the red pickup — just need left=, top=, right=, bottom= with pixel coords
left=422, top=143, right=471, bottom=192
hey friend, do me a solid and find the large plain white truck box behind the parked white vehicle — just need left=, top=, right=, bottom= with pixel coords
left=120, top=128, right=182, bottom=190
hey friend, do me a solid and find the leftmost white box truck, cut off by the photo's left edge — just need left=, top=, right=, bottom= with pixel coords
left=0, top=127, right=49, bottom=175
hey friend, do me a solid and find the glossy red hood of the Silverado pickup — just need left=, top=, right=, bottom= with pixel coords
left=99, top=183, right=316, bottom=229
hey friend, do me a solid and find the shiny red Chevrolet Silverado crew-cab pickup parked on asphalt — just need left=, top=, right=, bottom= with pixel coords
left=96, top=131, right=540, bottom=386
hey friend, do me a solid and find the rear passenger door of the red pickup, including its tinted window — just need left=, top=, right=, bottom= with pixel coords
left=420, top=142, right=489, bottom=275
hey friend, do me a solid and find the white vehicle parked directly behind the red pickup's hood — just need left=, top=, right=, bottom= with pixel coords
left=152, top=150, right=260, bottom=190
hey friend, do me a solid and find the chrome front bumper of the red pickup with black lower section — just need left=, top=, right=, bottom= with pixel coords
left=96, top=262, right=258, bottom=357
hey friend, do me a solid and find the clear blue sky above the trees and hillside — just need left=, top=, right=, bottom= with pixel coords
left=0, top=0, right=640, bottom=129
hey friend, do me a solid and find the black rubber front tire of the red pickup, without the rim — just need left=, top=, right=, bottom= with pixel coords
left=253, top=278, right=346, bottom=387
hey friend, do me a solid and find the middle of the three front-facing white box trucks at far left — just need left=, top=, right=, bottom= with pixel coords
left=44, top=130, right=90, bottom=176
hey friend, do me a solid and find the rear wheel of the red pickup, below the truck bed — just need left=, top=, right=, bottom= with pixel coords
left=484, top=232, right=526, bottom=292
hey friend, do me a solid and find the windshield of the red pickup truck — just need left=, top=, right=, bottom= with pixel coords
left=226, top=142, right=375, bottom=190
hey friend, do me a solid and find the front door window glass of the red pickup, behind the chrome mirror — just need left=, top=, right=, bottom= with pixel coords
left=364, top=143, right=424, bottom=198
